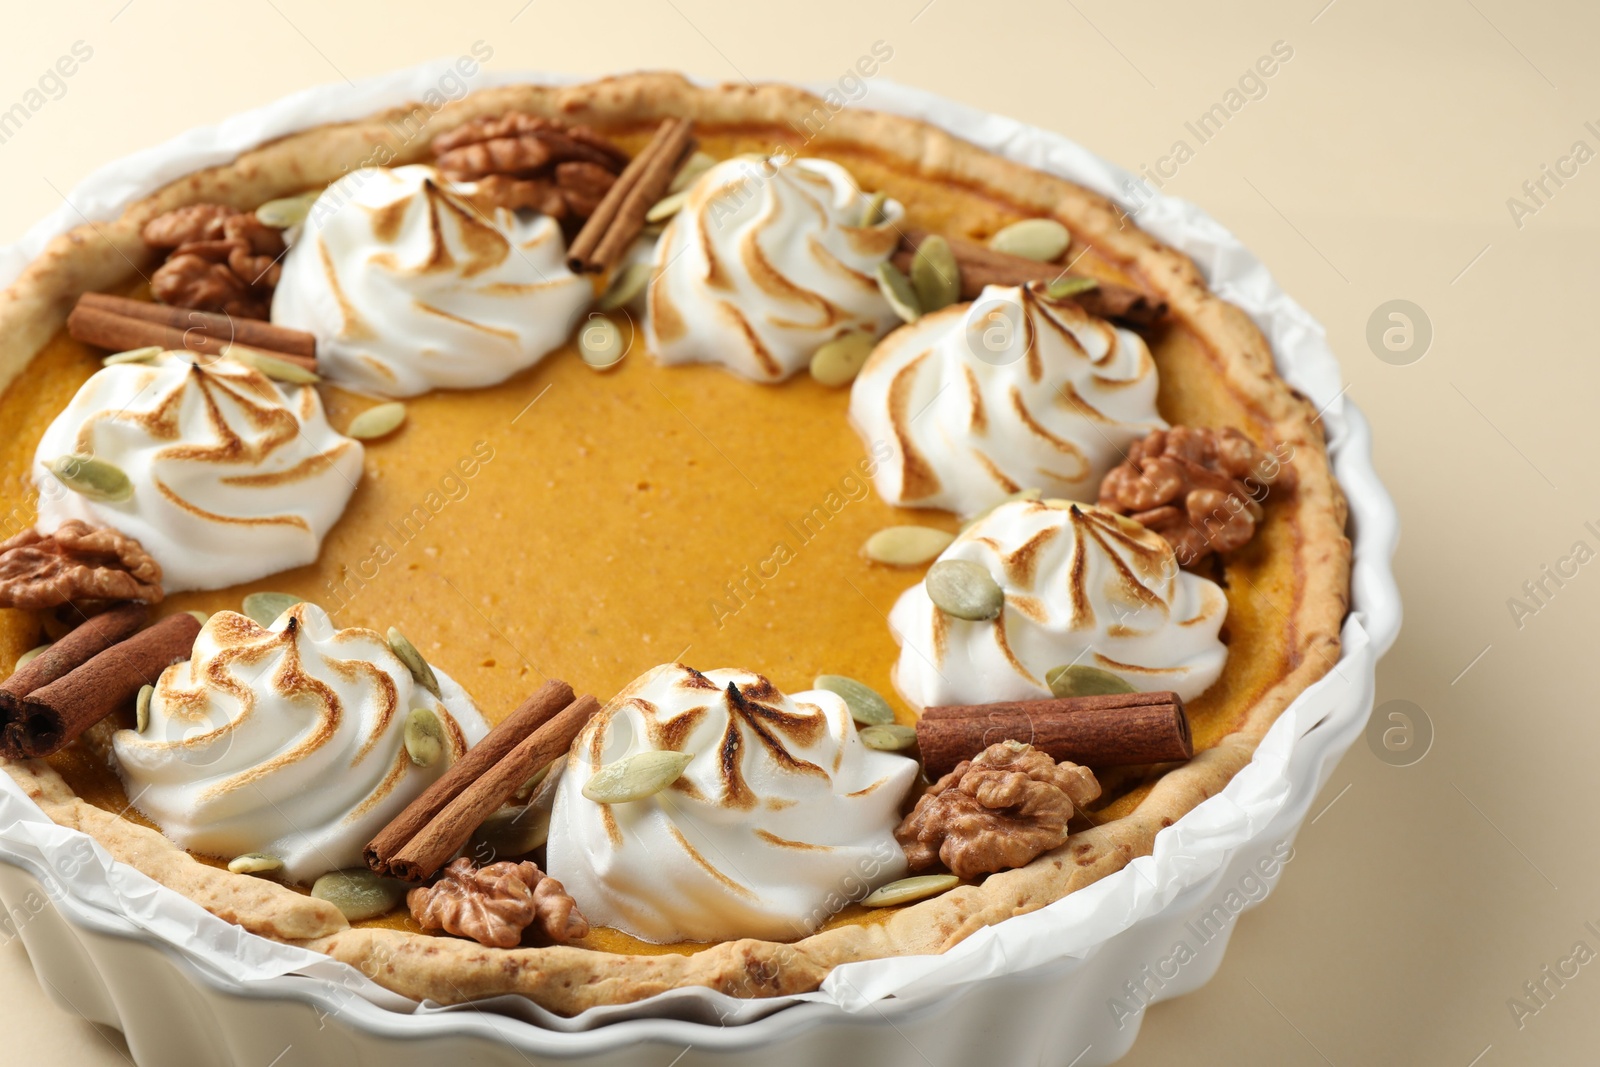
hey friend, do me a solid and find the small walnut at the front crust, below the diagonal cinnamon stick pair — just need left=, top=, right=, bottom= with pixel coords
left=406, top=856, right=589, bottom=949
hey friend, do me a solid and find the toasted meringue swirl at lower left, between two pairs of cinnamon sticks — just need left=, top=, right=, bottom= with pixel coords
left=112, top=603, right=488, bottom=881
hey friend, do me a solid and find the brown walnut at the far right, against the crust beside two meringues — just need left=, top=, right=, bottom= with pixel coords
left=1099, top=426, right=1296, bottom=566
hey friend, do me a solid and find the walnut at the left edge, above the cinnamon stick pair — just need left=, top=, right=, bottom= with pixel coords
left=0, top=518, right=162, bottom=611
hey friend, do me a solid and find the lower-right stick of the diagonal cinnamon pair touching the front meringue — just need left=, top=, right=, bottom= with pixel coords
left=389, top=696, right=600, bottom=881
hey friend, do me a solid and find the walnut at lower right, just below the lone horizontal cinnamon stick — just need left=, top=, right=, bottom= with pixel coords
left=894, top=741, right=1099, bottom=878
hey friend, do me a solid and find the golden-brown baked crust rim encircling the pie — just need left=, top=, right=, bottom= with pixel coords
left=0, top=74, right=1350, bottom=1014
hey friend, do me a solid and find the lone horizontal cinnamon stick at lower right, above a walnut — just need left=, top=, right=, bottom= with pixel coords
left=917, top=691, right=1194, bottom=777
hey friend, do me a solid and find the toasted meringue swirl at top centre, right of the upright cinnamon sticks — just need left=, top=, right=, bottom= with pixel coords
left=646, top=158, right=904, bottom=382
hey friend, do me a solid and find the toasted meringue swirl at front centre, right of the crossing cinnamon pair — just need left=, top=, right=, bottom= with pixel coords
left=547, top=664, right=917, bottom=944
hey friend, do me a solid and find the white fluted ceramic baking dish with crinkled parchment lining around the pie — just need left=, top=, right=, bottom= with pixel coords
left=0, top=64, right=1400, bottom=1067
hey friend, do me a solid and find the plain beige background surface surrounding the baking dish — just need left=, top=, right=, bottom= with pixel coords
left=0, top=0, right=1600, bottom=1067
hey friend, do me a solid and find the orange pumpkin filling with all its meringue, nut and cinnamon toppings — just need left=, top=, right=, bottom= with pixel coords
left=0, top=112, right=1298, bottom=953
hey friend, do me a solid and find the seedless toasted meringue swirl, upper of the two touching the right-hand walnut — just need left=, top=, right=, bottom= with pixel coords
left=850, top=285, right=1166, bottom=515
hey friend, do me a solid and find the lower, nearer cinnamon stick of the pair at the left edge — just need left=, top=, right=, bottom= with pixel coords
left=0, top=611, right=200, bottom=760
